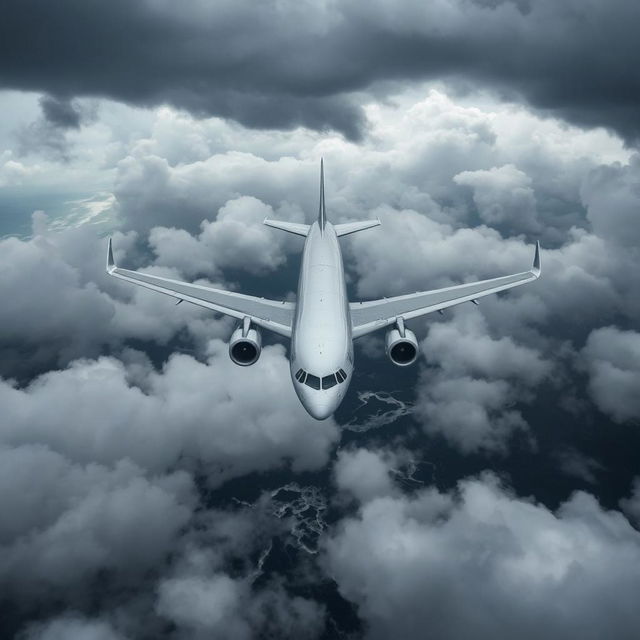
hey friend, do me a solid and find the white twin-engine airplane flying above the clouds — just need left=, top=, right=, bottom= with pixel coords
left=107, top=162, right=540, bottom=420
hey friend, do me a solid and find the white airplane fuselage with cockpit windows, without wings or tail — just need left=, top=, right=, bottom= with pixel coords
left=290, top=222, right=353, bottom=420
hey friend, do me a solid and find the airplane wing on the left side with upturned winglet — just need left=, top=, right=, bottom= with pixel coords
left=107, top=238, right=295, bottom=338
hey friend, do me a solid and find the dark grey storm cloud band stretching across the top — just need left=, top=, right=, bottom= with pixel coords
left=0, top=0, right=640, bottom=140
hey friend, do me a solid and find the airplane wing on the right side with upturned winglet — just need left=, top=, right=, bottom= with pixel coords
left=349, top=242, right=540, bottom=338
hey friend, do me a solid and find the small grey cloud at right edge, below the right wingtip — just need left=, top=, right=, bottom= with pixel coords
left=581, top=327, right=640, bottom=422
